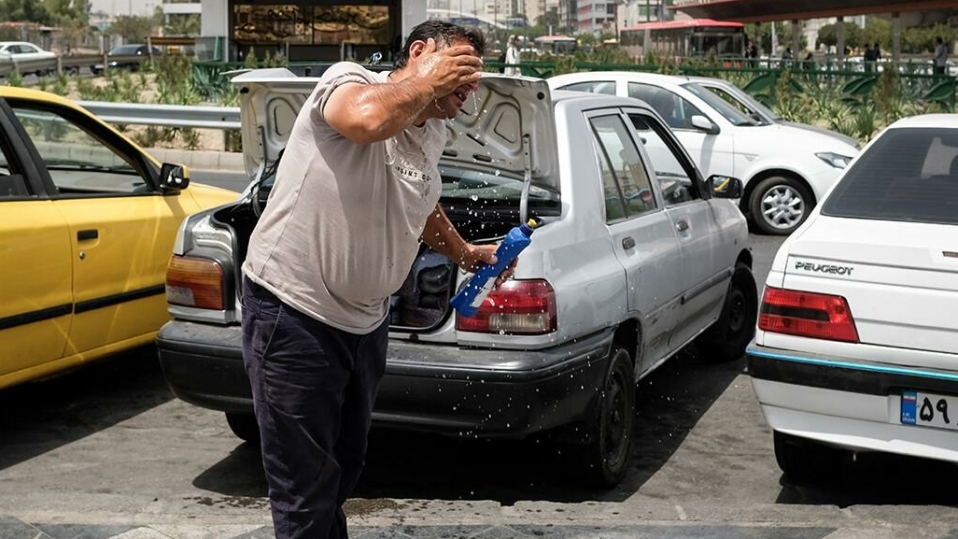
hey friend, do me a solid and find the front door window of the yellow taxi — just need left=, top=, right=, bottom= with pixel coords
left=10, top=100, right=149, bottom=195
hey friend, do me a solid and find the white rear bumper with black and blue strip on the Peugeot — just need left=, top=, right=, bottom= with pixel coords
left=746, top=344, right=958, bottom=462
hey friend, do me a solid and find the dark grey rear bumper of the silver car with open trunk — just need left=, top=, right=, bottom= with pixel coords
left=157, top=320, right=613, bottom=437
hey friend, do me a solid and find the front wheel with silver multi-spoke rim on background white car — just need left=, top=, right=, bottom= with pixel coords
left=749, top=176, right=814, bottom=236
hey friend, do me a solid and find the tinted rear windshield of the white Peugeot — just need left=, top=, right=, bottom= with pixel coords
left=822, top=128, right=958, bottom=224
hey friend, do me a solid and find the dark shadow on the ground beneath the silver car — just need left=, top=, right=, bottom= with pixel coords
left=193, top=347, right=744, bottom=505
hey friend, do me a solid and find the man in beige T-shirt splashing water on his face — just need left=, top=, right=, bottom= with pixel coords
left=242, top=20, right=512, bottom=539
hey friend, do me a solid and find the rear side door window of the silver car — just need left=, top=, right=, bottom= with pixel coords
left=590, top=114, right=657, bottom=222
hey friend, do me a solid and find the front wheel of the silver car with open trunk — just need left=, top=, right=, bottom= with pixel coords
left=696, top=263, right=758, bottom=362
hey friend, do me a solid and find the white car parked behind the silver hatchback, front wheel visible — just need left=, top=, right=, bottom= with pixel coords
left=547, top=71, right=858, bottom=235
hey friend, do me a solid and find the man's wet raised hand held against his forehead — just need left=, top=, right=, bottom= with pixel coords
left=412, top=38, right=482, bottom=98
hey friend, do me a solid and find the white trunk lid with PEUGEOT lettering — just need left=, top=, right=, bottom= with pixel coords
left=784, top=215, right=958, bottom=353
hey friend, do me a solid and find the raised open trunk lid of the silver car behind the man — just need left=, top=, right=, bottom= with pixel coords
left=232, top=68, right=559, bottom=193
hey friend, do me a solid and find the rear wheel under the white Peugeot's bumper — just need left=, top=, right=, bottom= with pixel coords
left=773, top=431, right=848, bottom=485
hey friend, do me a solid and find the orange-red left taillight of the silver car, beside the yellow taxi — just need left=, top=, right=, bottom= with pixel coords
left=166, top=255, right=224, bottom=311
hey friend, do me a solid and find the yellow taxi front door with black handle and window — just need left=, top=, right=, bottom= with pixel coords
left=5, top=101, right=198, bottom=359
